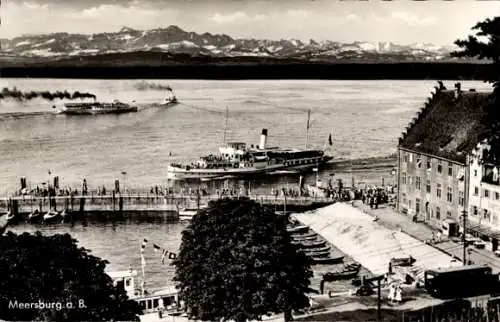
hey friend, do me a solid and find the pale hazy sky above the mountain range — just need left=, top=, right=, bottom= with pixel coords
left=0, top=0, right=500, bottom=45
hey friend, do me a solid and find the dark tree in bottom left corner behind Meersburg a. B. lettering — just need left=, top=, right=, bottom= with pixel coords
left=0, top=232, right=140, bottom=321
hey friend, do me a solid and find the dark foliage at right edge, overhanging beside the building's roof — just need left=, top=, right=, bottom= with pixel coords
left=452, top=17, right=500, bottom=162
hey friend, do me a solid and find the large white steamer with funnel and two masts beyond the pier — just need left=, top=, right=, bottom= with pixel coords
left=167, top=129, right=333, bottom=180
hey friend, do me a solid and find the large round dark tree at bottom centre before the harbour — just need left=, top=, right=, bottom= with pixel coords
left=173, top=199, right=312, bottom=321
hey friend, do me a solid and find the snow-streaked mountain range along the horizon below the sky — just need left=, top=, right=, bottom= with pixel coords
left=0, top=26, right=454, bottom=61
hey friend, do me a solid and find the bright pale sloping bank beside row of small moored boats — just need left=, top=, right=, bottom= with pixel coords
left=294, top=203, right=461, bottom=280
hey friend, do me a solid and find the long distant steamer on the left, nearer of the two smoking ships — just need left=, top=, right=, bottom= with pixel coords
left=59, top=100, right=137, bottom=115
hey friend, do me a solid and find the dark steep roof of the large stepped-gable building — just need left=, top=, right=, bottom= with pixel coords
left=399, top=90, right=490, bottom=163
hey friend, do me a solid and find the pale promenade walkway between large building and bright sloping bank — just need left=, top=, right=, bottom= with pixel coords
left=352, top=200, right=500, bottom=273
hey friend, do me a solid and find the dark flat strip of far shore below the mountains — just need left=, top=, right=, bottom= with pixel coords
left=0, top=61, right=490, bottom=81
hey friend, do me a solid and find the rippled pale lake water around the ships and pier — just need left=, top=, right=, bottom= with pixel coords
left=0, top=79, right=488, bottom=287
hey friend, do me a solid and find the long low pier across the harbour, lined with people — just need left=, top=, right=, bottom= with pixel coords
left=0, top=193, right=334, bottom=215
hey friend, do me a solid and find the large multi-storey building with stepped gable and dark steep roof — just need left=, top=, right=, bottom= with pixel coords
left=397, top=84, right=489, bottom=227
